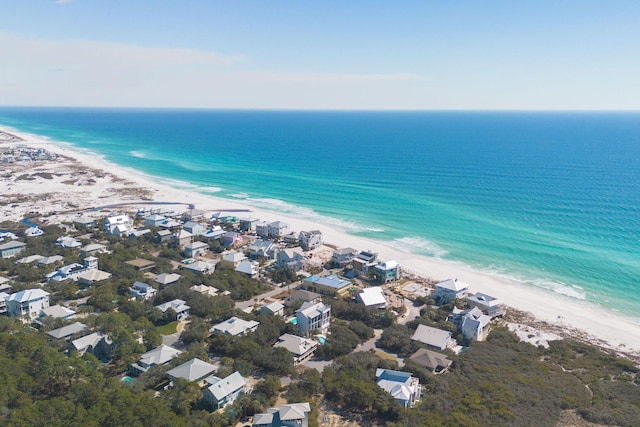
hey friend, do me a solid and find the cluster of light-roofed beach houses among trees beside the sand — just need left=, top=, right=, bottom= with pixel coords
left=0, top=203, right=632, bottom=426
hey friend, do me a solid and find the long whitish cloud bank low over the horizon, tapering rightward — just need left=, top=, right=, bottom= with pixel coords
left=0, top=31, right=426, bottom=109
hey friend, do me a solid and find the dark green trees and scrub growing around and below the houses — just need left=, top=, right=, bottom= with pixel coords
left=0, top=224, right=640, bottom=427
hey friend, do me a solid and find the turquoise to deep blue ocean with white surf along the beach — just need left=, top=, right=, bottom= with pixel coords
left=0, top=107, right=640, bottom=317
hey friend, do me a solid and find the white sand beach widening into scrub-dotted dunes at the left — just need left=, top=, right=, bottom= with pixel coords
left=0, top=127, right=640, bottom=359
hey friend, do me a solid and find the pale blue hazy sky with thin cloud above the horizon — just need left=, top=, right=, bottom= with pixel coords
left=0, top=0, right=640, bottom=110
